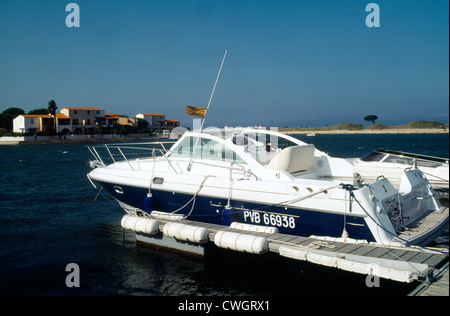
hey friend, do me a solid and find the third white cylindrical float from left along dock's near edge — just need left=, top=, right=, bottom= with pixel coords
left=214, top=230, right=269, bottom=254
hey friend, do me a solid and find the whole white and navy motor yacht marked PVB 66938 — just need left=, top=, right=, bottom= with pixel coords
left=87, top=128, right=448, bottom=245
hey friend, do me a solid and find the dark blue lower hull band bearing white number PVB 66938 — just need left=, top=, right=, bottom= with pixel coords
left=100, top=183, right=375, bottom=242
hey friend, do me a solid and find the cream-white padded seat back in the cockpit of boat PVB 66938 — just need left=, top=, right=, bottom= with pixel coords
left=265, top=144, right=315, bottom=173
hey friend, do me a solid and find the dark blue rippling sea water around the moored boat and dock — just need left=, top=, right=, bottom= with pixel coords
left=0, top=134, right=449, bottom=296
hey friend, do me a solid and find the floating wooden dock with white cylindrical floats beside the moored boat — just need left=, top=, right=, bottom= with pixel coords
left=121, top=213, right=449, bottom=293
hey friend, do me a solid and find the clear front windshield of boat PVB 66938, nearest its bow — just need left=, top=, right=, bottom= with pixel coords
left=169, top=136, right=246, bottom=164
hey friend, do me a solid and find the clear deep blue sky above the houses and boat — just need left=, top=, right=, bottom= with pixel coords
left=0, top=0, right=449, bottom=127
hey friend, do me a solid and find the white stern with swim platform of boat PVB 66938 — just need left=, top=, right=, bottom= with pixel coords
left=354, top=169, right=442, bottom=245
